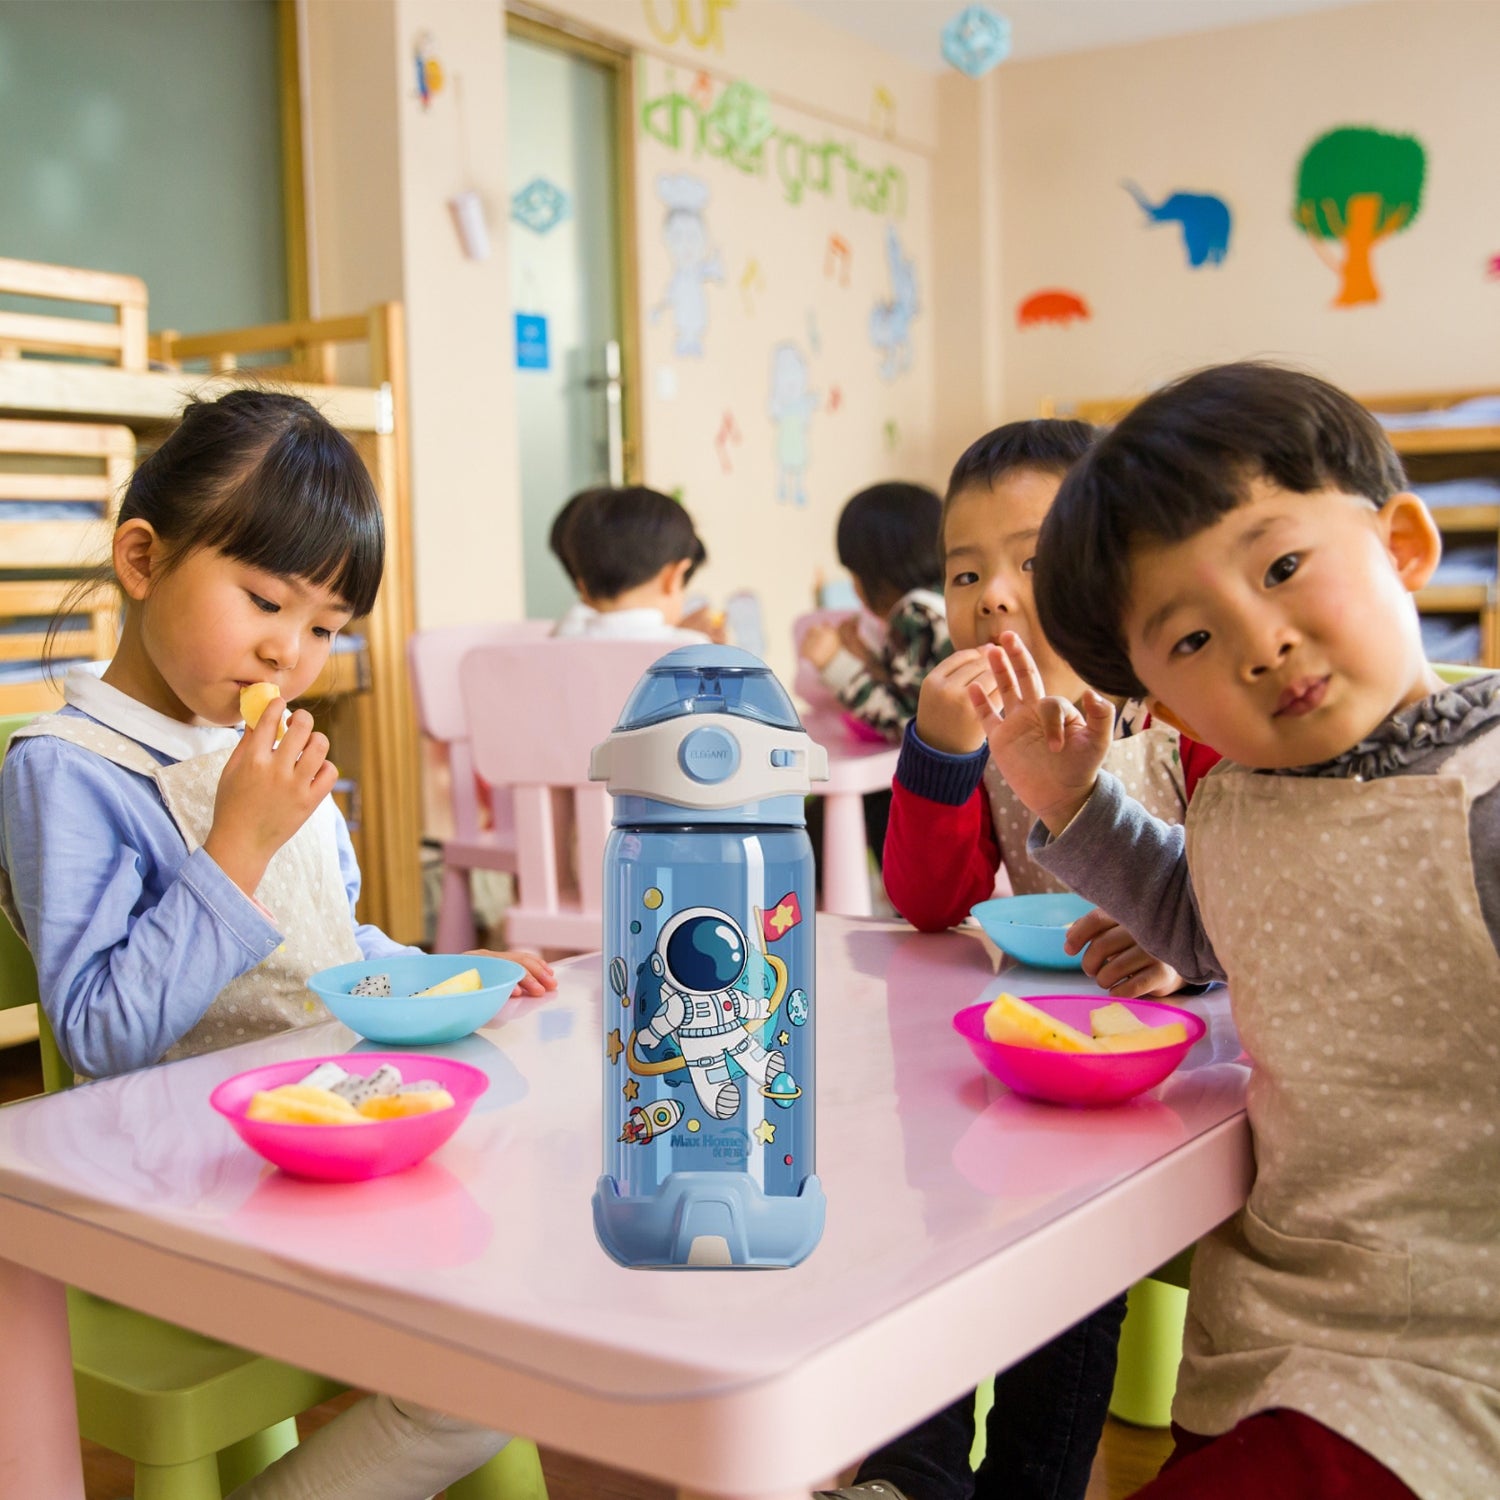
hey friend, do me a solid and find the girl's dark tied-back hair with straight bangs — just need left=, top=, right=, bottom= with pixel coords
left=116, top=390, right=386, bottom=615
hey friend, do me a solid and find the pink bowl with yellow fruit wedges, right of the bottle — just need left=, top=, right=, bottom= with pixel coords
left=953, top=995, right=1208, bottom=1106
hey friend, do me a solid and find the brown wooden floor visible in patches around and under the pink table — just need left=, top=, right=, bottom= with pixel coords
left=0, top=1044, right=1172, bottom=1500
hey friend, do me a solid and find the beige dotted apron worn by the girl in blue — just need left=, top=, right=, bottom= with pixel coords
left=0, top=714, right=363, bottom=1062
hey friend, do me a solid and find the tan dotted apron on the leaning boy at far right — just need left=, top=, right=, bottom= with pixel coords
left=1173, top=731, right=1500, bottom=1500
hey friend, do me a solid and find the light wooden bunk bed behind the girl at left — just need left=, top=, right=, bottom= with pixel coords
left=0, top=260, right=423, bottom=944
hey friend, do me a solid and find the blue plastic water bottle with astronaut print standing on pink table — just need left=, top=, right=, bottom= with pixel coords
left=590, top=645, right=828, bottom=1266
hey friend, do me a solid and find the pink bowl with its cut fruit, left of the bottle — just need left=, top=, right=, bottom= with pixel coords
left=209, top=1052, right=489, bottom=1182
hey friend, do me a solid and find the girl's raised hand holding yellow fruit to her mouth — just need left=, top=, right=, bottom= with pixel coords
left=203, top=699, right=339, bottom=896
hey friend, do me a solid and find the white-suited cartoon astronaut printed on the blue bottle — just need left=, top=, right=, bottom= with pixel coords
left=636, top=906, right=786, bottom=1121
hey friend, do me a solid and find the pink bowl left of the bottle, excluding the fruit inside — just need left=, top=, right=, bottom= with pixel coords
left=209, top=1052, right=489, bottom=1182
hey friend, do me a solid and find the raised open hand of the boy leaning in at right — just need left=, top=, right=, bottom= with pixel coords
left=969, top=630, right=1115, bottom=834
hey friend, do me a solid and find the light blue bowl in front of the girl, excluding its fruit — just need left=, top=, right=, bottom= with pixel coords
left=308, top=953, right=527, bottom=1047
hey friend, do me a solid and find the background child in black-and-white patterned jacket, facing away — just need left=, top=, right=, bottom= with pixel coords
left=798, top=482, right=953, bottom=741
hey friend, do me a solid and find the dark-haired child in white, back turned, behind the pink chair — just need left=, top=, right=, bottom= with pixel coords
left=549, top=485, right=725, bottom=645
